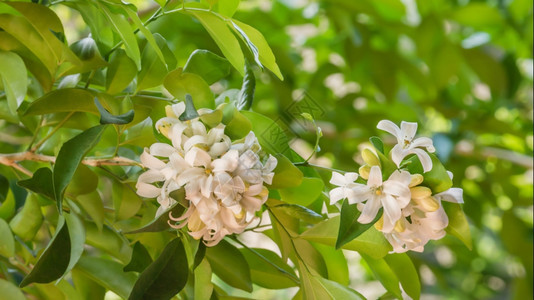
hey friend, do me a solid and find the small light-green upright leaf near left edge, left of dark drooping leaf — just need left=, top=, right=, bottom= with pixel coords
left=9, top=193, right=43, bottom=241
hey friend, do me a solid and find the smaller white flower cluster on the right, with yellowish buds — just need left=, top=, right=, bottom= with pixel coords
left=330, top=120, right=463, bottom=253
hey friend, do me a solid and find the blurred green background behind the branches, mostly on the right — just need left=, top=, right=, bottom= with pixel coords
left=53, top=0, right=533, bottom=299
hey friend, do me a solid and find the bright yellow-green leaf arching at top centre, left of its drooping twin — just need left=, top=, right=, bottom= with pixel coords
left=188, top=11, right=245, bottom=75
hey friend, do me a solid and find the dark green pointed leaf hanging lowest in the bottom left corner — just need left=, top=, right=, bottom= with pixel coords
left=20, top=216, right=71, bottom=287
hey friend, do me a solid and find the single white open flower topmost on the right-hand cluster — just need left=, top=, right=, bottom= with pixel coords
left=376, top=120, right=436, bottom=172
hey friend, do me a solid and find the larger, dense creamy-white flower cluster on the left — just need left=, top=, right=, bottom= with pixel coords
left=136, top=102, right=277, bottom=246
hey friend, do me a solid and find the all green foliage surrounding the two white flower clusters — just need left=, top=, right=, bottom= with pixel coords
left=0, top=0, right=534, bottom=299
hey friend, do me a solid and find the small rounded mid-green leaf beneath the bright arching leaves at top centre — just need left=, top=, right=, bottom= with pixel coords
left=184, top=49, right=231, bottom=85
